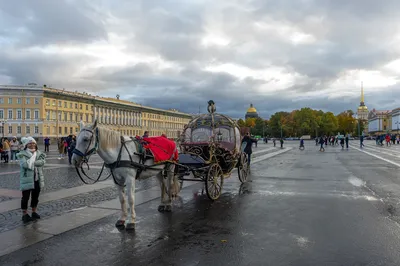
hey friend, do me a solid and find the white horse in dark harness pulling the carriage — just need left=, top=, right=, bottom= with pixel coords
left=72, top=119, right=179, bottom=230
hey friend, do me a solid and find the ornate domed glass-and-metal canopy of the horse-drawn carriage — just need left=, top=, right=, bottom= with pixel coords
left=181, top=108, right=241, bottom=154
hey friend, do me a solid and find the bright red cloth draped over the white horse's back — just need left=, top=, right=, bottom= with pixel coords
left=142, top=136, right=178, bottom=163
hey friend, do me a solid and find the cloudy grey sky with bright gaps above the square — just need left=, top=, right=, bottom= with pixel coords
left=0, top=0, right=400, bottom=118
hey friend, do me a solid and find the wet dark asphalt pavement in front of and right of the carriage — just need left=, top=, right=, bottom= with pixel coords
left=0, top=142, right=400, bottom=265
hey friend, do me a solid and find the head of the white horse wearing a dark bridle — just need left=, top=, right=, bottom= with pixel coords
left=72, top=119, right=99, bottom=167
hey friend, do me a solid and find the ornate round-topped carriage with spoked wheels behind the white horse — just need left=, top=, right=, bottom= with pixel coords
left=175, top=101, right=249, bottom=200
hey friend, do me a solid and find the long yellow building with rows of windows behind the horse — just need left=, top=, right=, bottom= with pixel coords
left=0, top=85, right=192, bottom=139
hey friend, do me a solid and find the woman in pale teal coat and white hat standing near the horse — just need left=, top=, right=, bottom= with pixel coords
left=17, top=137, right=46, bottom=223
